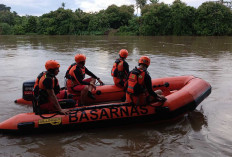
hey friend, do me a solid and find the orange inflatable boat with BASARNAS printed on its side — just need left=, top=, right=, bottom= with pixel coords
left=0, top=76, right=211, bottom=132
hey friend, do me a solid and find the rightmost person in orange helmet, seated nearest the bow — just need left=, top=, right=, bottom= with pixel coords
left=125, top=56, right=166, bottom=105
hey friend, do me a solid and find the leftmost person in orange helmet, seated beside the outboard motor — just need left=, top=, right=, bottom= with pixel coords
left=33, top=60, right=76, bottom=114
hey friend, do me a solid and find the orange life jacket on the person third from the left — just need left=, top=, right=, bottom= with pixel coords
left=111, top=58, right=127, bottom=79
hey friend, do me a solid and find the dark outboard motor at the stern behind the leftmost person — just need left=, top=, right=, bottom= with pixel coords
left=23, top=80, right=35, bottom=101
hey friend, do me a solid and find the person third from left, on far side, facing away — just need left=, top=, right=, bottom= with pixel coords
left=111, top=49, right=129, bottom=88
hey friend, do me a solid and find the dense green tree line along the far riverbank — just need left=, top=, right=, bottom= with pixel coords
left=0, top=0, right=232, bottom=36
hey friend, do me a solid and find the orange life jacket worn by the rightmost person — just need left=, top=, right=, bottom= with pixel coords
left=127, top=68, right=146, bottom=96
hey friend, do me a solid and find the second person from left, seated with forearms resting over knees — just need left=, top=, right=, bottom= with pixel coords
left=65, top=54, right=103, bottom=105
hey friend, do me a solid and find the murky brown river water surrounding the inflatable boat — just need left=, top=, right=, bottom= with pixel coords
left=0, top=36, right=232, bottom=157
